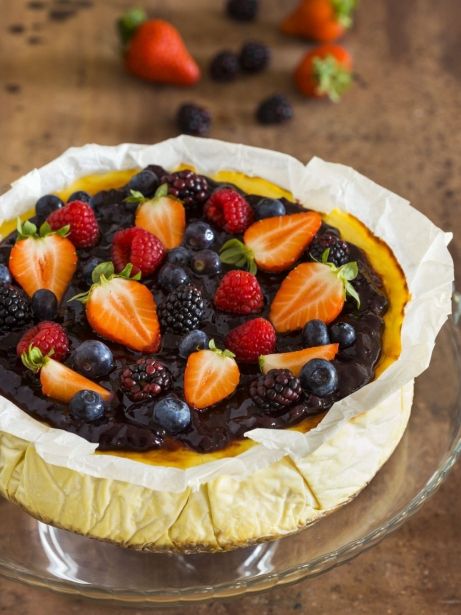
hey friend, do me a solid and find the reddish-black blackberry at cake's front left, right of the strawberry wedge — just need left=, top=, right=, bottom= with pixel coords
left=120, top=357, right=172, bottom=401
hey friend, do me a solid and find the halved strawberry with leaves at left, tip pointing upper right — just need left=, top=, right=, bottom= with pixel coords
left=221, top=211, right=322, bottom=273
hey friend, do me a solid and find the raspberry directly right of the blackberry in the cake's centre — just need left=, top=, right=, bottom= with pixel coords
left=214, top=269, right=264, bottom=314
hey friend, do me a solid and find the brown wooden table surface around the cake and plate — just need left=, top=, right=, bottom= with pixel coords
left=0, top=0, right=461, bottom=615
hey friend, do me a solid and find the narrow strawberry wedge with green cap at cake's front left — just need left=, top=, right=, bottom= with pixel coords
left=21, top=346, right=112, bottom=403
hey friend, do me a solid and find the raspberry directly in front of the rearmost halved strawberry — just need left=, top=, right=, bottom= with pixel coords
left=112, top=226, right=166, bottom=278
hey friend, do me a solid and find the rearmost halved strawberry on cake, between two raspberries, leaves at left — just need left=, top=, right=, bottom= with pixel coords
left=131, top=184, right=186, bottom=250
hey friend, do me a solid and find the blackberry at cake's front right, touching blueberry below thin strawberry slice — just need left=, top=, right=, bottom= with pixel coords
left=250, top=369, right=302, bottom=410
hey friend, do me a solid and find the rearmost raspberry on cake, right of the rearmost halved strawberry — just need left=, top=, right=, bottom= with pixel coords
left=204, top=188, right=254, bottom=233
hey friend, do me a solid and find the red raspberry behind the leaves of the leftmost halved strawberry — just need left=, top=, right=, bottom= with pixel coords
left=47, top=201, right=100, bottom=248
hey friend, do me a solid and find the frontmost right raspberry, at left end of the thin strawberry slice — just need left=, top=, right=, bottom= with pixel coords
left=226, top=318, right=277, bottom=363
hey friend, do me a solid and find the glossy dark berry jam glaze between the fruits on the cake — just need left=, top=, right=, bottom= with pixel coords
left=0, top=167, right=388, bottom=453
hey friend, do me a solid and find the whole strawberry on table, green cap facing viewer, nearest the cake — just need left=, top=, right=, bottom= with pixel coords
left=294, top=44, right=352, bottom=102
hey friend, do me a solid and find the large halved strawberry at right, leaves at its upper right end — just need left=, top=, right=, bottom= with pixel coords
left=269, top=250, right=360, bottom=333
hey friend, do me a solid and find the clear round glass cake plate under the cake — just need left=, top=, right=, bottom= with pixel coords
left=0, top=304, right=461, bottom=608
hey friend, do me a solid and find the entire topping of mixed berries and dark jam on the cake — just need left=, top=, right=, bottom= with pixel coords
left=0, top=165, right=389, bottom=453
